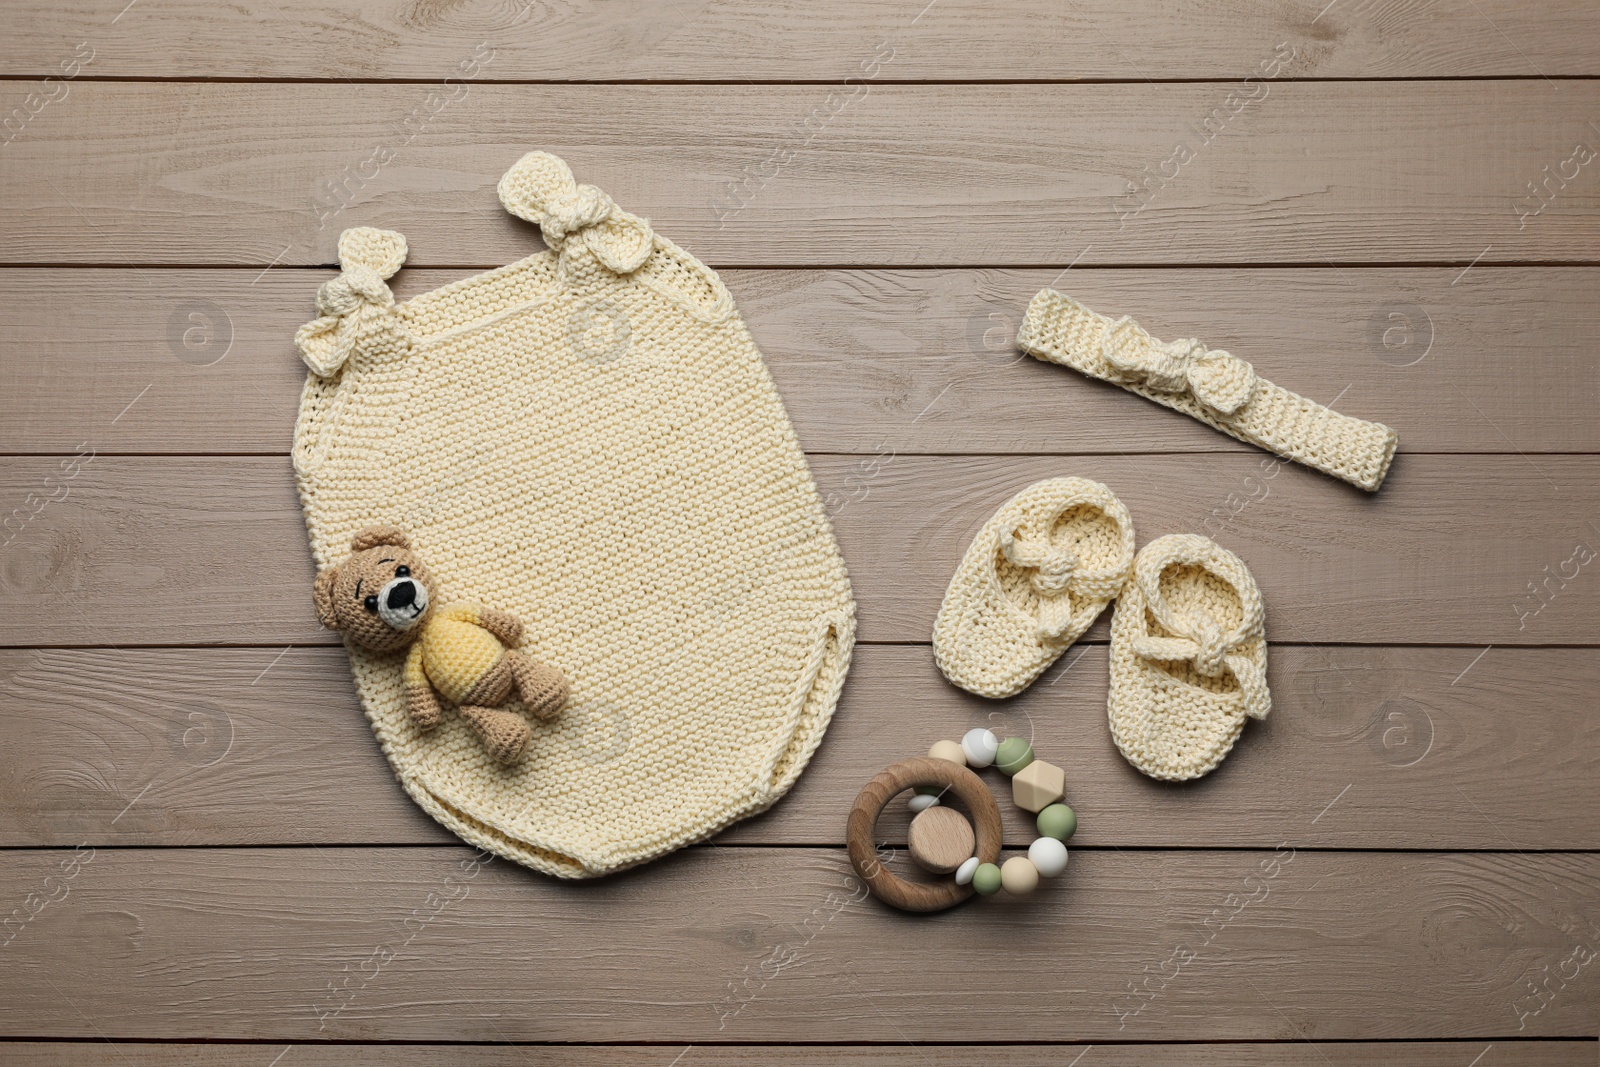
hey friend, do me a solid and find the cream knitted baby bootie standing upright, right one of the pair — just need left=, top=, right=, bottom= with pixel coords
left=1107, top=534, right=1272, bottom=781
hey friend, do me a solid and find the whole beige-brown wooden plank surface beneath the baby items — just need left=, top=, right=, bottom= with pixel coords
left=0, top=0, right=1600, bottom=1067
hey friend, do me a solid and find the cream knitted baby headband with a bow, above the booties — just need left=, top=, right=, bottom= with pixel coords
left=1016, top=290, right=1400, bottom=491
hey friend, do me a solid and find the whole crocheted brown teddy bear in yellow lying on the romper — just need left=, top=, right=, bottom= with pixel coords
left=314, top=526, right=566, bottom=763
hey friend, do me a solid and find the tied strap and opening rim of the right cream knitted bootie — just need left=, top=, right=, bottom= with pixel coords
left=1133, top=539, right=1272, bottom=718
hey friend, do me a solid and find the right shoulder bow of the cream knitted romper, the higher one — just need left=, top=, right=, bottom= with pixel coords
left=499, top=152, right=656, bottom=274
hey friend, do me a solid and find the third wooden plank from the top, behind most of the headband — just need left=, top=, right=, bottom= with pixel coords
left=0, top=267, right=1600, bottom=454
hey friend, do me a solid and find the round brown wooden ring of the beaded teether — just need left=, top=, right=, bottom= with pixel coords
left=845, top=757, right=1000, bottom=912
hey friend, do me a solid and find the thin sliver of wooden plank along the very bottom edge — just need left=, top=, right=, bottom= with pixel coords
left=0, top=1040, right=1594, bottom=1067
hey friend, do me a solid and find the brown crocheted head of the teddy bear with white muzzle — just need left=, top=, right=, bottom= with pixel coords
left=314, top=526, right=434, bottom=653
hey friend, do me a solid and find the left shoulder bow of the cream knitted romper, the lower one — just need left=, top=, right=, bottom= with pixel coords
left=294, top=226, right=406, bottom=378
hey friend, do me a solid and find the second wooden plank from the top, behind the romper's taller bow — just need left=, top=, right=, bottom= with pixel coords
left=0, top=80, right=1600, bottom=272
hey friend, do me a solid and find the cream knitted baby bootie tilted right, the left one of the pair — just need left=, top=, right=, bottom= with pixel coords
left=933, top=478, right=1133, bottom=697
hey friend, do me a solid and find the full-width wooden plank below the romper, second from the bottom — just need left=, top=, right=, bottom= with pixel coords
left=0, top=832, right=1600, bottom=1036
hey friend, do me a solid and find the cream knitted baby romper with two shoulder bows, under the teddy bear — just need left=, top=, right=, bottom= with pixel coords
left=294, top=152, right=854, bottom=878
